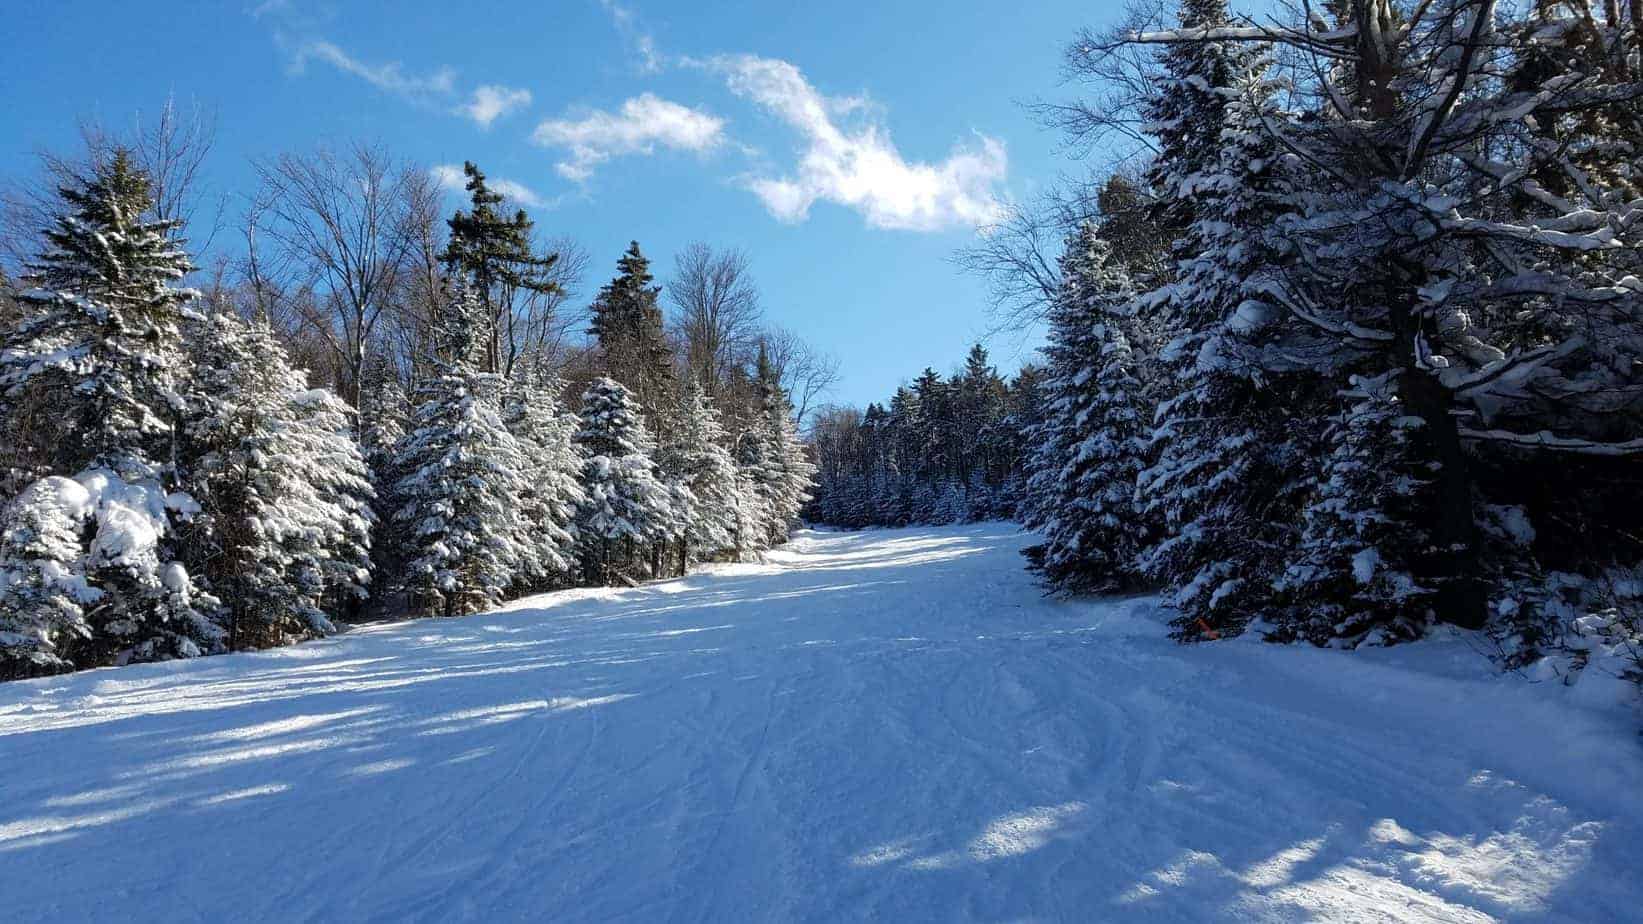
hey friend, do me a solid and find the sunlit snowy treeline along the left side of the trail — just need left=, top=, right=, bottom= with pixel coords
left=0, top=138, right=818, bottom=679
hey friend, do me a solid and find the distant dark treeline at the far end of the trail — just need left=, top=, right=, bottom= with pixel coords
left=808, top=344, right=1042, bottom=528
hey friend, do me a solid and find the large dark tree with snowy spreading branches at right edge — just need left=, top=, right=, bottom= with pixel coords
left=1137, top=0, right=1643, bottom=638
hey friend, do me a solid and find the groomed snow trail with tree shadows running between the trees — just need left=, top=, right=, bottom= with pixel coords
left=0, top=524, right=1643, bottom=922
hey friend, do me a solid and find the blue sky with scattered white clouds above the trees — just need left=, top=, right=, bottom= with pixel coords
left=0, top=0, right=1111, bottom=403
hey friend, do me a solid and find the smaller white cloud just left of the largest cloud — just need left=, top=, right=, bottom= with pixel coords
left=532, top=94, right=725, bottom=182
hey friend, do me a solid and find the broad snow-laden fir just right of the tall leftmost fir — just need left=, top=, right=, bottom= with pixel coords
left=184, top=314, right=373, bottom=649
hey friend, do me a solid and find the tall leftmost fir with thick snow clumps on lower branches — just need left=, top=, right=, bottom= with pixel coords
left=0, top=151, right=223, bottom=669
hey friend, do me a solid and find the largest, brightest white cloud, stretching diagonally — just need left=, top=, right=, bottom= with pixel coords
left=698, top=54, right=1009, bottom=230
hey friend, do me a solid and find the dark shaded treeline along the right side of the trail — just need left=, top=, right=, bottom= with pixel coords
left=822, top=0, right=1643, bottom=672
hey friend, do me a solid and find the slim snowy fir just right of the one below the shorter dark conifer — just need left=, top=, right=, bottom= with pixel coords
left=656, top=380, right=743, bottom=571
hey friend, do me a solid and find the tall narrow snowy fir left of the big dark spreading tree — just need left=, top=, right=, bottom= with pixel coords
left=1139, top=54, right=1316, bottom=638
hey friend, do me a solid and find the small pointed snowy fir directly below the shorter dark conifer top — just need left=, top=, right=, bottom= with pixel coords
left=577, top=378, right=674, bottom=584
